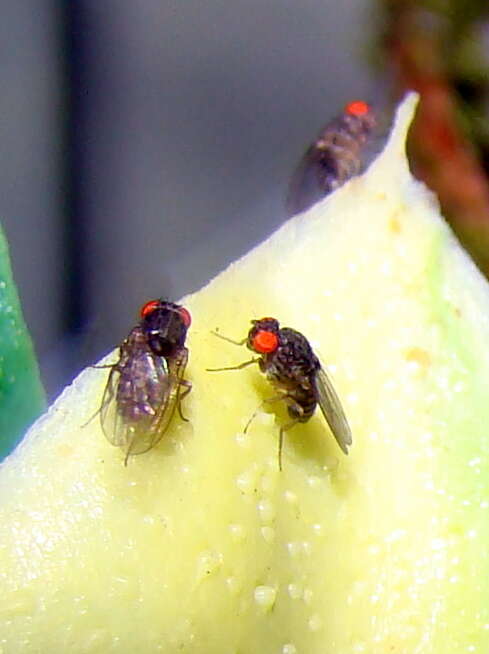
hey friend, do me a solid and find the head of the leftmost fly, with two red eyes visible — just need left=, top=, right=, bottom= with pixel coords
left=141, top=300, right=192, bottom=357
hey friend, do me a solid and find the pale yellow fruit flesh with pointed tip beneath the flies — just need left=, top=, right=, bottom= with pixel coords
left=0, top=96, right=489, bottom=654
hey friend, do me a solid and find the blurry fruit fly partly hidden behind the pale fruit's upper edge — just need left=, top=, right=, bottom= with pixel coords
left=287, top=100, right=378, bottom=215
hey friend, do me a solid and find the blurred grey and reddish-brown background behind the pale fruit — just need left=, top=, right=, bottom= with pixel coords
left=0, top=0, right=489, bottom=398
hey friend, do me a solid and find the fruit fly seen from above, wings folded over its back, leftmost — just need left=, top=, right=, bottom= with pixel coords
left=99, top=300, right=191, bottom=465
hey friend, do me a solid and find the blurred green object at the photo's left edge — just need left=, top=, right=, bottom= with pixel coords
left=0, top=228, right=46, bottom=460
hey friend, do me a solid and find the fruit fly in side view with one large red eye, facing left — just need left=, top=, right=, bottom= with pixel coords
left=208, top=318, right=352, bottom=470
